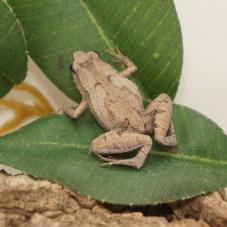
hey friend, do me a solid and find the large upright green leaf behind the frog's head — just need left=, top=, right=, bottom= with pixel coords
left=9, top=0, right=182, bottom=101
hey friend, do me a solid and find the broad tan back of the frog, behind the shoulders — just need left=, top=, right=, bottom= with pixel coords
left=89, top=74, right=144, bottom=132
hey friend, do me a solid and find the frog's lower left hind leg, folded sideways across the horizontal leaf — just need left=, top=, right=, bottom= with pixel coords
left=91, top=130, right=152, bottom=169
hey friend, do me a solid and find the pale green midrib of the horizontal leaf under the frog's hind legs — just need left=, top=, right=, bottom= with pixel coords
left=16, top=141, right=227, bottom=165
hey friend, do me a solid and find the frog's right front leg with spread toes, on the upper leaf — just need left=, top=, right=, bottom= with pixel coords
left=109, top=48, right=137, bottom=77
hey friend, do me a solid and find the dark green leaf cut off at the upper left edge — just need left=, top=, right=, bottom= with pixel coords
left=0, top=0, right=27, bottom=97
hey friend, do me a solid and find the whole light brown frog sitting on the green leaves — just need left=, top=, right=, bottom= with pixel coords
left=64, top=48, right=178, bottom=169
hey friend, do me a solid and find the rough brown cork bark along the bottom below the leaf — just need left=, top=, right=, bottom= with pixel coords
left=0, top=173, right=227, bottom=227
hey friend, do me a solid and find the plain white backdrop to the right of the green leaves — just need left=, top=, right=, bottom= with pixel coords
left=174, top=0, right=227, bottom=133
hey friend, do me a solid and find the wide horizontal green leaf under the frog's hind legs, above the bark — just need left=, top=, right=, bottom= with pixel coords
left=0, top=106, right=227, bottom=205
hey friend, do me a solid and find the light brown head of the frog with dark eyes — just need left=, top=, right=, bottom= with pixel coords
left=70, top=51, right=99, bottom=73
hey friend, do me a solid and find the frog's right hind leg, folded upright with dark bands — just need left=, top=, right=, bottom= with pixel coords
left=144, top=94, right=178, bottom=146
